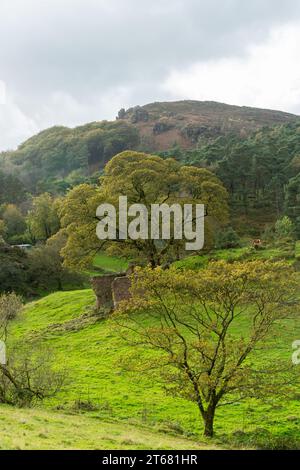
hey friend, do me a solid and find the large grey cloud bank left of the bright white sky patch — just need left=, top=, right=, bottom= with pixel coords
left=0, top=0, right=300, bottom=147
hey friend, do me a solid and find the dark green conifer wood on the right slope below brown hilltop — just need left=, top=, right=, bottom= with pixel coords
left=177, top=121, right=300, bottom=235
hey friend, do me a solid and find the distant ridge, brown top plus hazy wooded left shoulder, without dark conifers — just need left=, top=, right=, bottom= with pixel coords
left=0, top=101, right=298, bottom=193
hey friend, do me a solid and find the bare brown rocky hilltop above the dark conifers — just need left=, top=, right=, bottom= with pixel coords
left=117, top=100, right=298, bottom=151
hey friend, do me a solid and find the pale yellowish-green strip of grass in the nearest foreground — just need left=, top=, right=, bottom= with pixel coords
left=0, top=406, right=218, bottom=450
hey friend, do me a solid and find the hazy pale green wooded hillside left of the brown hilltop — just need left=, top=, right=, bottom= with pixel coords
left=0, top=121, right=139, bottom=197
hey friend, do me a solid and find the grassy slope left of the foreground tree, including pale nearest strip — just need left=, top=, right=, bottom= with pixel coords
left=6, top=290, right=218, bottom=449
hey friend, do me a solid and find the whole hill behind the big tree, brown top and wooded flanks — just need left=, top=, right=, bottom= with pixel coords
left=0, top=101, right=300, bottom=236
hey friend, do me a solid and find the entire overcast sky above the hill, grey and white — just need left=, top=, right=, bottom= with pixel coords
left=0, top=0, right=300, bottom=150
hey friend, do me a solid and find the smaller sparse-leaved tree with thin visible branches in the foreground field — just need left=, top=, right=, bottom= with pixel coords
left=114, top=261, right=300, bottom=437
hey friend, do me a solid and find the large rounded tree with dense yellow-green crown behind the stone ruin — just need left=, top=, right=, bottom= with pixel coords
left=61, top=151, right=228, bottom=267
